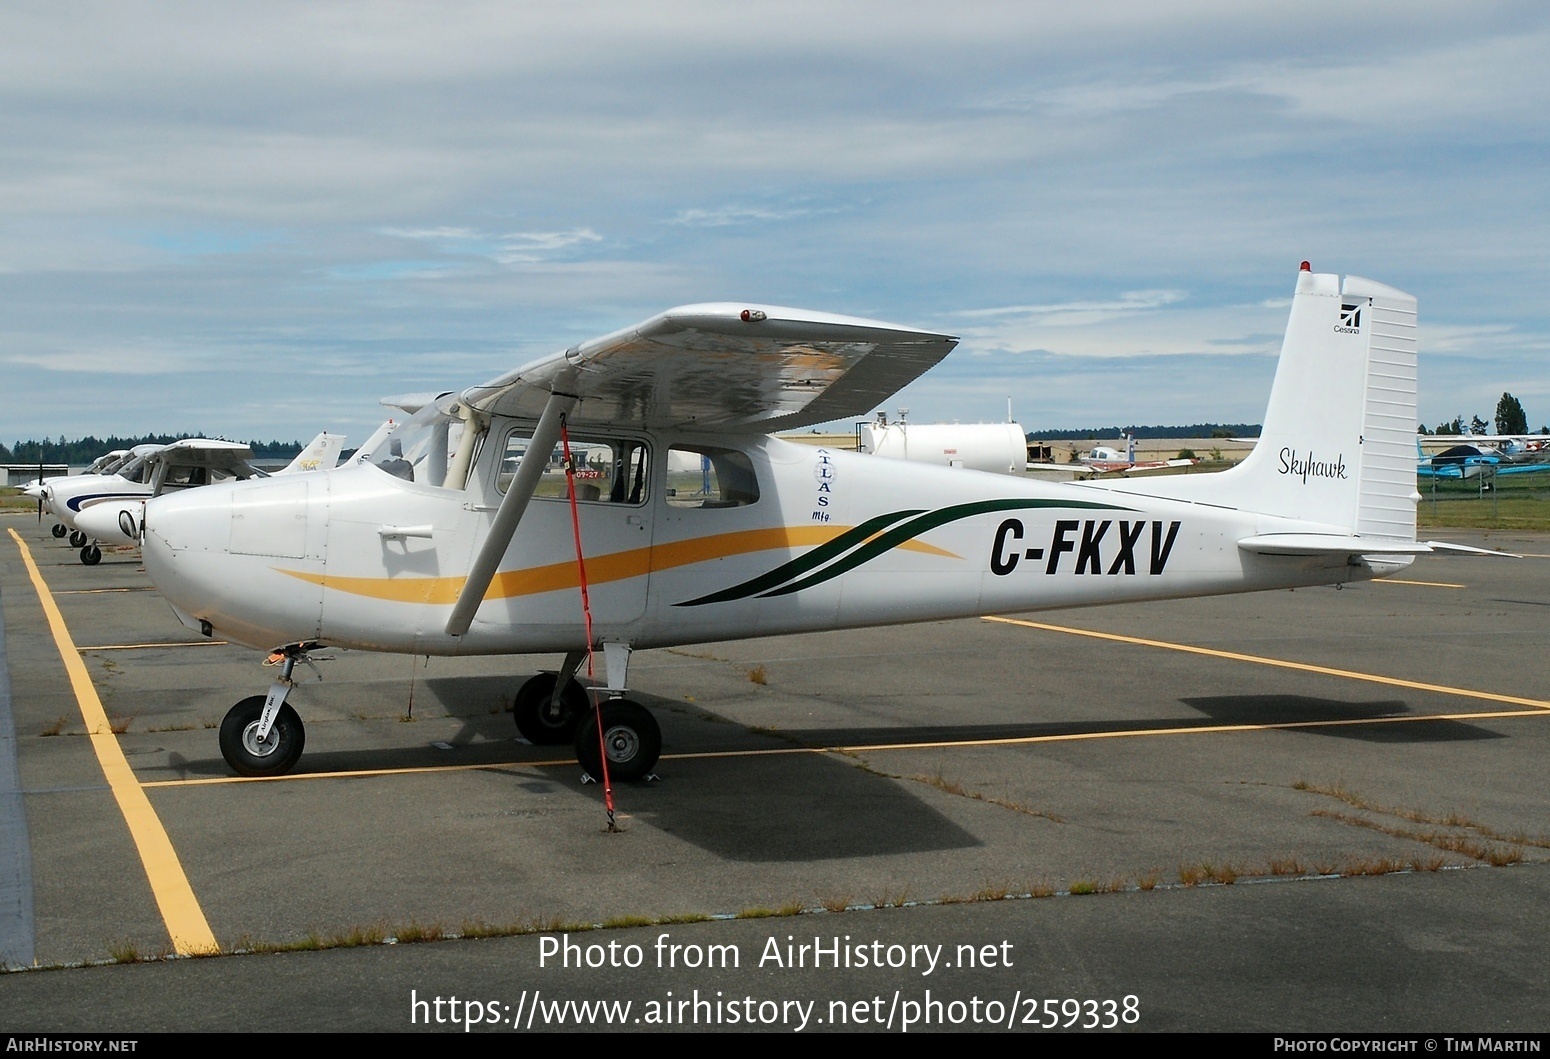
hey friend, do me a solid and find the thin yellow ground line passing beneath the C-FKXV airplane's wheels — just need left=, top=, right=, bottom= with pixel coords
left=143, top=710, right=1550, bottom=788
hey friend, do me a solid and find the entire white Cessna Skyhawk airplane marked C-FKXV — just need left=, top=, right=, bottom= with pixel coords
left=144, top=264, right=1488, bottom=778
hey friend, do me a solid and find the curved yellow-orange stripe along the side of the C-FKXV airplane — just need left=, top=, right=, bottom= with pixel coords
left=274, top=526, right=963, bottom=606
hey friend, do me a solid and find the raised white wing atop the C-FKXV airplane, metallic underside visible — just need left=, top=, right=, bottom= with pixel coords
left=463, top=302, right=958, bottom=433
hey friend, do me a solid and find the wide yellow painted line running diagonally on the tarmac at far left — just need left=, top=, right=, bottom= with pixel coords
left=8, top=529, right=220, bottom=955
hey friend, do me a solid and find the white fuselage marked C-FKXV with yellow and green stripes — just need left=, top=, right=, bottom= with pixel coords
left=144, top=419, right=1397, bottom=654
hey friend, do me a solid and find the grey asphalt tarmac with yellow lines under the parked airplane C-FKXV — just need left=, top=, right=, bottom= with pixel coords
left=0, top=516, right=1550, bottom=1033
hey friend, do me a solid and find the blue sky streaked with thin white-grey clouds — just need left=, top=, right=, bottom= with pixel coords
left=0, top=0, right=1550, bottom=442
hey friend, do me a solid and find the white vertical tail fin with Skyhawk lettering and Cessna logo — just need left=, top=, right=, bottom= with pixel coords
left=1116, top=267, right=1417, bottom=540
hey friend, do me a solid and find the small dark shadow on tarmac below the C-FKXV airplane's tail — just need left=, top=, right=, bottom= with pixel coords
left=1180, top=695, right=1505, bottom=743
